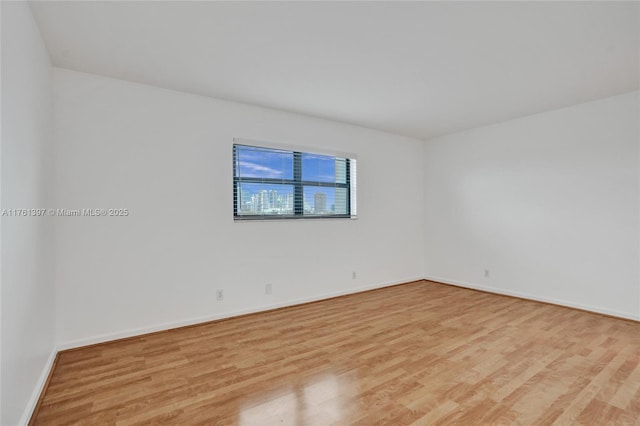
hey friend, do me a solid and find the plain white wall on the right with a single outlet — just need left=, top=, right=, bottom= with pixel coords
left=424, top=91, right=640, bottom=319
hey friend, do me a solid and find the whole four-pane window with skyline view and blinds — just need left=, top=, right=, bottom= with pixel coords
left=233, top=143, right=356, bottom=219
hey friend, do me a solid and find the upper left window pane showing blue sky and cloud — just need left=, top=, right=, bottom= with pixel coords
left=236, top=145, right=293, bottom=180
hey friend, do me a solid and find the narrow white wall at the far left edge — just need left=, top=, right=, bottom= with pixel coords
left=0, top=2, right=54, bottom=425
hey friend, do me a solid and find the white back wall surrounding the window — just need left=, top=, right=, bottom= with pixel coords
left=54, top=69, right=423, bottom=347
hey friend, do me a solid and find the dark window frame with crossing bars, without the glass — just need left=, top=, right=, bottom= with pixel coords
left=232, top=138, right=357, bottom=221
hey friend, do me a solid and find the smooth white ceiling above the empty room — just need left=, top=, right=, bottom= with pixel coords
left=31, top=1, right=640, bottom=139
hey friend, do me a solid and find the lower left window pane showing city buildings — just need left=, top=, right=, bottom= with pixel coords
left=236, top=182, right=294, bottom=215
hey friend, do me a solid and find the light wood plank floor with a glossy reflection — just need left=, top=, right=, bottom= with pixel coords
left=32, top=282, right=640, bottom=426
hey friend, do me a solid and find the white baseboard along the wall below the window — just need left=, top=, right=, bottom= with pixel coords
left=58, top=276, right=423, bottom=351
